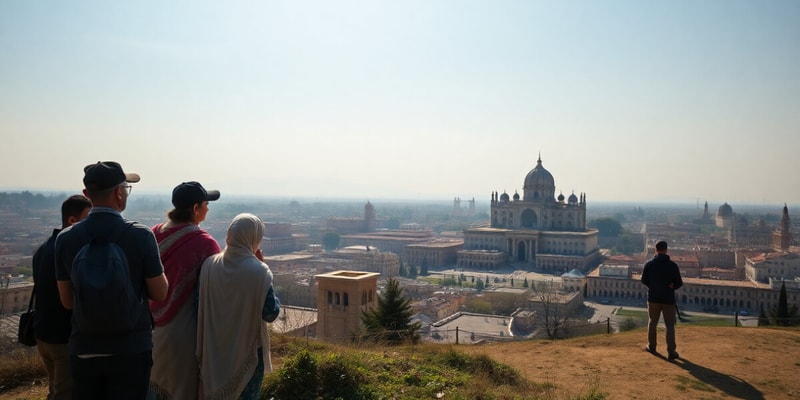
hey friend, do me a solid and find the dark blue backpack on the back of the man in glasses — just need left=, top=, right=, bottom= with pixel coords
left=70, top=222, right=144, bottom=334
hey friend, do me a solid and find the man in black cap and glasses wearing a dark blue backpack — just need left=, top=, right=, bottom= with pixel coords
left=55, top=161, right=168, bottom=399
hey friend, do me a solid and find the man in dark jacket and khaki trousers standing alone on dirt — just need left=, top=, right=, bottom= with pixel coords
left=642, top=240, right=683, bottom=360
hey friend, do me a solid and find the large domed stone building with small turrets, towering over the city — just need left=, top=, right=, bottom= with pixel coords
left=458, top=156, right=601, bottom=272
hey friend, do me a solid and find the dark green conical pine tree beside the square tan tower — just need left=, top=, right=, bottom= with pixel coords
left=361, top=278, right=422, bottom=345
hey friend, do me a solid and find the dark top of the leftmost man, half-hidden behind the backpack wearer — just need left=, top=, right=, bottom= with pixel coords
left=33, top=229, right=72, bottom=344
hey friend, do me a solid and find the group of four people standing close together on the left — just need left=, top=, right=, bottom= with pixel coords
left=33, top=161, right=280, bottom=399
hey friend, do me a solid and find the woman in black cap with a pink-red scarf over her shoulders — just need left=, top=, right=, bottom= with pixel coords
left=148, top=182, right=220, bottom=399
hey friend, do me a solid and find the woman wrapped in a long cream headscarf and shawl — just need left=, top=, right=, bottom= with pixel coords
left=197, top=213, right=280, bottom=399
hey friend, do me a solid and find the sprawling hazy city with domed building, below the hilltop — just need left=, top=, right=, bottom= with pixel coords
left=0, top=156, right=800, bottom=344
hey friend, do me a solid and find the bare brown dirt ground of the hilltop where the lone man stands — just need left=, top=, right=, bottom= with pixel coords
left=0, top=325, right=800, bottom=400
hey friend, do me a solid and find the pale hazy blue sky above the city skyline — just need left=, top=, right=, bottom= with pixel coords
left=0, top=0, right=800, bottom=205
